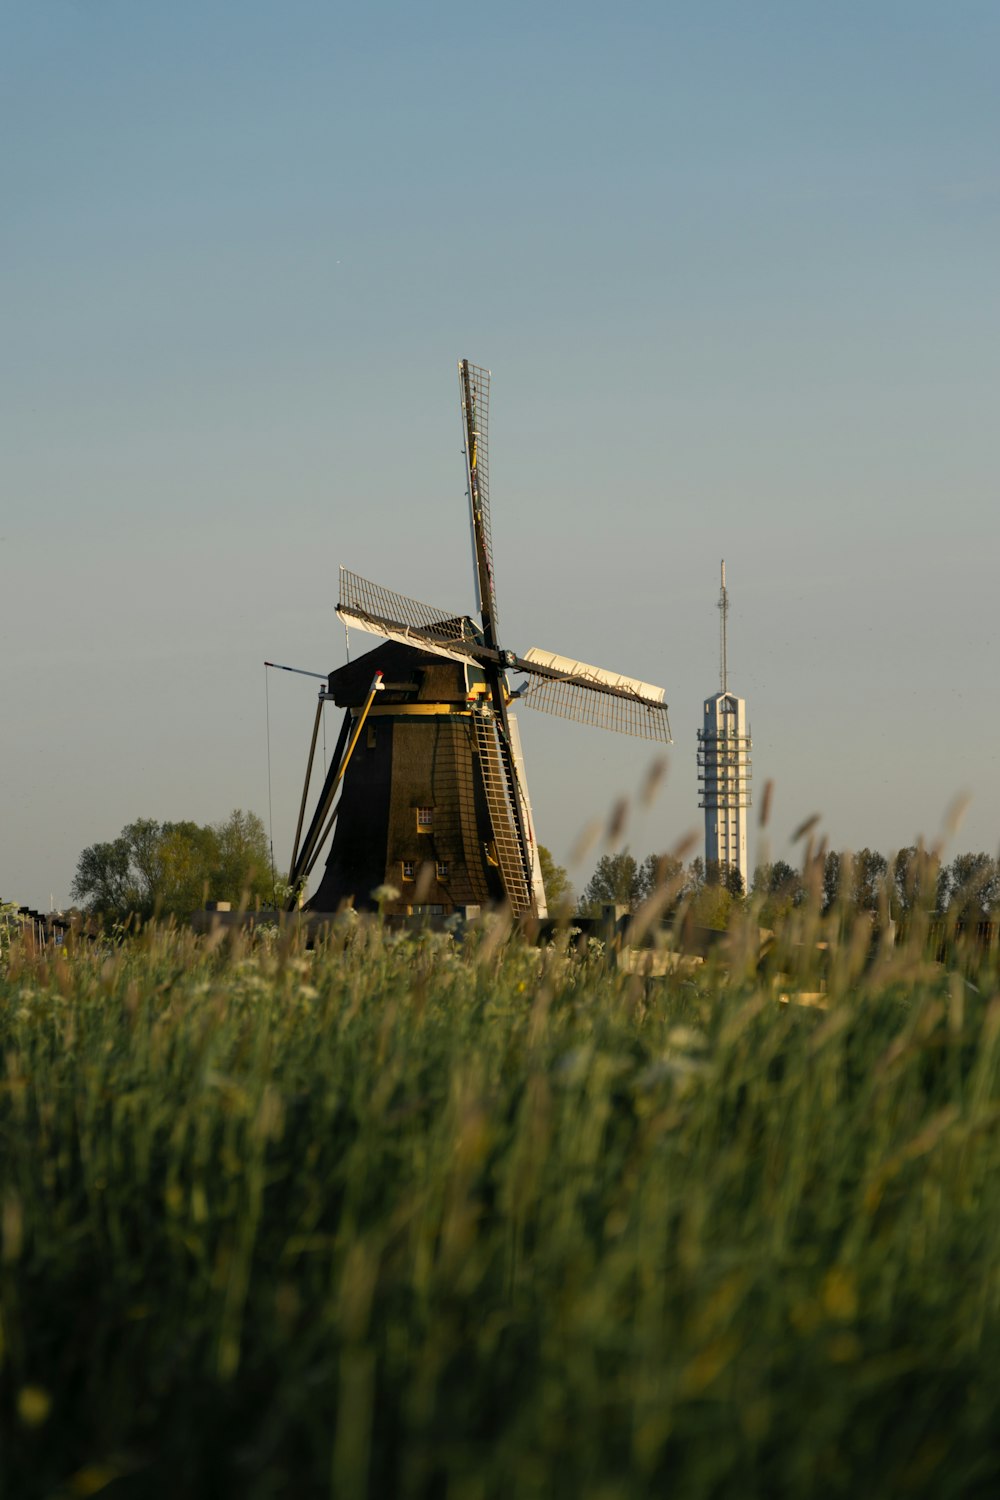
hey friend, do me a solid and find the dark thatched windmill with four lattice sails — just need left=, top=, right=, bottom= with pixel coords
left=289, top=360, right=670, bottom=917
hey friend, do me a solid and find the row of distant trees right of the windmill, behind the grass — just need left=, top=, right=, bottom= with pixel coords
left=580, top=845, right=1000, bottom=927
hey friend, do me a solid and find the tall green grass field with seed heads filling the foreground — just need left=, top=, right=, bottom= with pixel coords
left=0, top=924, right=1000, bottom=1500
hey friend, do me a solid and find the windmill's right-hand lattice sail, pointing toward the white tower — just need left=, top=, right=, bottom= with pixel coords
left=517, top=647, right=670, bottom=744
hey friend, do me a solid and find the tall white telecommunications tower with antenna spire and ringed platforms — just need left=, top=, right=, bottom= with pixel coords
left=699, top=563, right=753, bottom=890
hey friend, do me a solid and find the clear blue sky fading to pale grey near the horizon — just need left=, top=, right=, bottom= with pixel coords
left=0, top=0, right=1000, bottom=906
